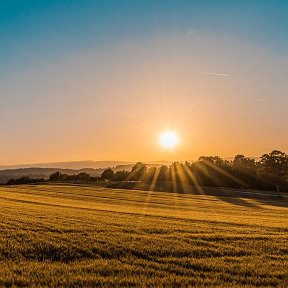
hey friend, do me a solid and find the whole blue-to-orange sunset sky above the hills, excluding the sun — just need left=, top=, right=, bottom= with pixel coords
left=0, top=0, right=288, bottom=165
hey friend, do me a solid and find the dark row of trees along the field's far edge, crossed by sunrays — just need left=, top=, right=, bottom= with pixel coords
left=6, top=150, right=288, bottom=191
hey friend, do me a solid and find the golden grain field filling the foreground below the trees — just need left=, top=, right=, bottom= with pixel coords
left=0, top=184, right=288, bottom=287
